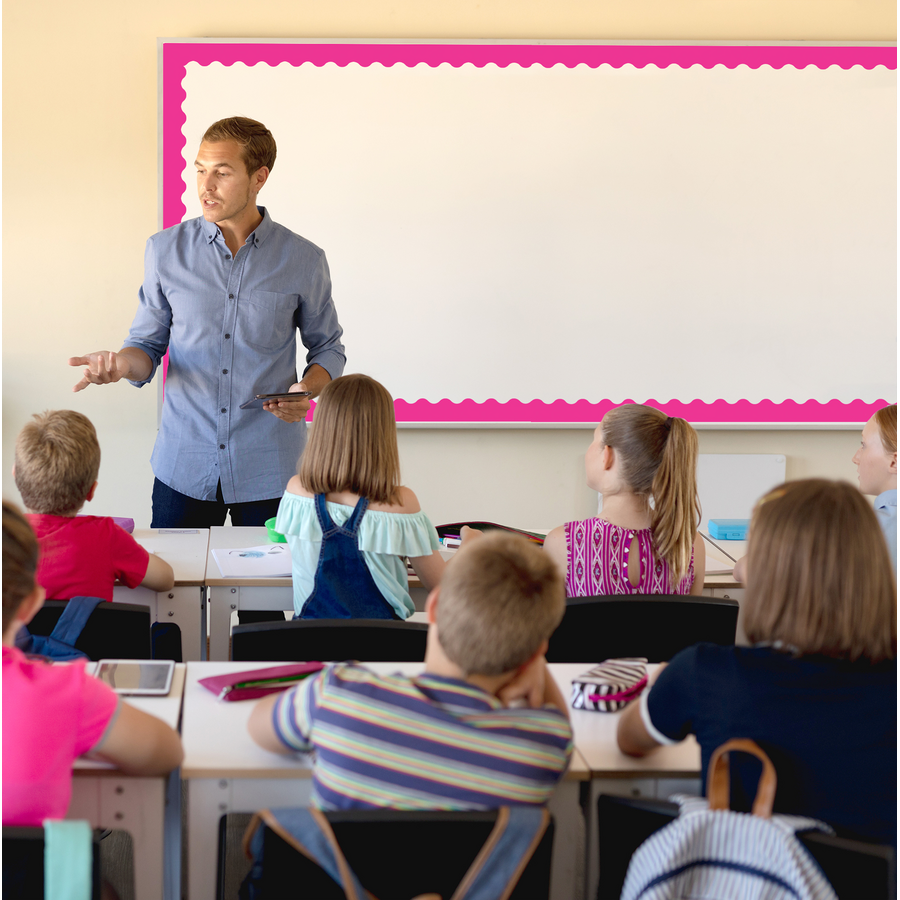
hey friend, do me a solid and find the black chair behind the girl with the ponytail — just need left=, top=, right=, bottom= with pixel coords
left=547, top=594, right=738, bottom=662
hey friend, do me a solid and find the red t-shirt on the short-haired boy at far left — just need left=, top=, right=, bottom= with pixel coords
left=28, top=513, right=150, bottom=600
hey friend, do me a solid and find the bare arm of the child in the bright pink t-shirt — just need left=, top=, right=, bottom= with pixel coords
left=88, top=701, right=184, bottom=775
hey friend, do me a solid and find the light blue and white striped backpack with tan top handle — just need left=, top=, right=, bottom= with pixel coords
left=622, top=738, right=838, bottom=900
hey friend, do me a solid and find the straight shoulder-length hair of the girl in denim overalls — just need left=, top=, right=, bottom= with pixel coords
left=297, top=375, right=400, bottom=504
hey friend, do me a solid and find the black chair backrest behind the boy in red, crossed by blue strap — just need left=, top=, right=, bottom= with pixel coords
left=28, top=600, right=151, bottom=660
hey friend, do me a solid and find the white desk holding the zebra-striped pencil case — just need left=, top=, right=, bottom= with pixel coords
left=550, top=663, right=701, bottom=900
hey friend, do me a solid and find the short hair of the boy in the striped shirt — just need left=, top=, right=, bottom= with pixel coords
left=437, top=531, right=566, bottom=675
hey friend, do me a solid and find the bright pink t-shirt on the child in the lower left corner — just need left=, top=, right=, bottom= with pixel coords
left=3, top=647, right=119, bottom=825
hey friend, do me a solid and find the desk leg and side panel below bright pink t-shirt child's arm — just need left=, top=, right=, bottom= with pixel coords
left=68, top=776, right=165, bottom=900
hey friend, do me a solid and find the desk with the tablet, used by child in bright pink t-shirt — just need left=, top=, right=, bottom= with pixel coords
left=67, top=663, right=187, bottom=900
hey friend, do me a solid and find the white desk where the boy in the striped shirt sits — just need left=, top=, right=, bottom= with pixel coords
left=181, top=662, right=589, bottom=900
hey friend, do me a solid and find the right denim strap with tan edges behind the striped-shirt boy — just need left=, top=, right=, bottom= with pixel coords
left=451, top=806, right=550, bottom=900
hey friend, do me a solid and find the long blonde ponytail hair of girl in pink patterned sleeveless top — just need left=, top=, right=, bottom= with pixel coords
left=601, top=403, right=700, bottom=581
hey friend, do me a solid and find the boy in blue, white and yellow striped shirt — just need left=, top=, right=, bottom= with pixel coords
left=249, top=533, right=572, bottom=810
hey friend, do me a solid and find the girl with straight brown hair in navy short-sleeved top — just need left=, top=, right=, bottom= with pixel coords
left=618, top=479, right=897, bottom=847
